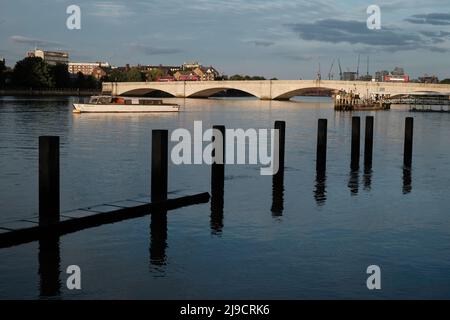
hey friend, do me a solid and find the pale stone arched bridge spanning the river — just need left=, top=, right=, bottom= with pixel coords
left=102, top=80, right=450, bottom=100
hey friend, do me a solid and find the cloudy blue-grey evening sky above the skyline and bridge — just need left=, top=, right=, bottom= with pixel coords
left=0, top=0, right=450, bottom=79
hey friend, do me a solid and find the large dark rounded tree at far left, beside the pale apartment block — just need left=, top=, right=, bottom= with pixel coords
left=13, top=57, right=53, bottom=88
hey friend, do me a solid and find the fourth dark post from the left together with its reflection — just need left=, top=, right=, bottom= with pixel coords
left=271, top=121, right=286, bottom=217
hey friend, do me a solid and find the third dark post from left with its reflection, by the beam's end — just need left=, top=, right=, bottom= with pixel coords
left=210, top=126, right=225, bottom=234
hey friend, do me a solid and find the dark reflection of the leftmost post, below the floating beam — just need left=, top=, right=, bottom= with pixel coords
left=39, top=235, right=61, bottom=298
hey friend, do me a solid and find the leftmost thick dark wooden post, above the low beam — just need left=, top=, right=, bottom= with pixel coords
left=39, top=136, right=60, bottom=227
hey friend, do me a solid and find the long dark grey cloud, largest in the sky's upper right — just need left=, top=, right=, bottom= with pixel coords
left=287, top=19, right=447, bottom=52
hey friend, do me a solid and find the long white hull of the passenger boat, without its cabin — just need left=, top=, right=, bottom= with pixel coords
left=73, top=103, right=180, bottom=113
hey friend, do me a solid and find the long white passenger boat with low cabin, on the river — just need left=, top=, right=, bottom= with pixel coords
left=73, top=96, right=180, bottom=113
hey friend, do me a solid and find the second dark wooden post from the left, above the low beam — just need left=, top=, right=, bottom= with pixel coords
left=151, top=130, right=169, bottom=202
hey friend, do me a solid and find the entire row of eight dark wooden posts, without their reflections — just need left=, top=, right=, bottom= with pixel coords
left=39, top=116, right=413, bottom=227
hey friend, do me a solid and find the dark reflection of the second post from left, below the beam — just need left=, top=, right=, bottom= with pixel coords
left=150, top=211, right=167, bottom=266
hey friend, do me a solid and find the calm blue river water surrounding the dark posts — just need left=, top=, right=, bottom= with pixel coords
left=0, top=97, right=450, bottom=299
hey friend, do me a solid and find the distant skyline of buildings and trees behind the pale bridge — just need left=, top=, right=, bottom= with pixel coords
left=0, top=49, right=450, bottom=88
